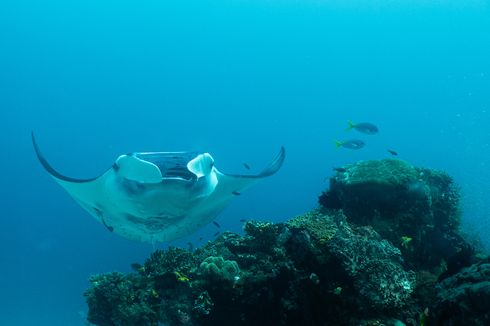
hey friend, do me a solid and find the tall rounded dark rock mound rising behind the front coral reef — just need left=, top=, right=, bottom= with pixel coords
left=319, top=159, right=466, bottom=272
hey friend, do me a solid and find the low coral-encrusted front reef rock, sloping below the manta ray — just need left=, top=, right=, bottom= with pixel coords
left=85, top=215, right=413, bottom=325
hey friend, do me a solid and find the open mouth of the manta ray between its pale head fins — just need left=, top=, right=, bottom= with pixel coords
left=133, top=152, right=198, bottom=181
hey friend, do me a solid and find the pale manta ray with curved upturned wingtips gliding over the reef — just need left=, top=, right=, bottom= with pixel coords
left=32, top=133, right=286, bottom=243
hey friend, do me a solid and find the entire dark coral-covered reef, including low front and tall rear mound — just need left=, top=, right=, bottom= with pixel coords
left=85, top=159, right=490, bottom=325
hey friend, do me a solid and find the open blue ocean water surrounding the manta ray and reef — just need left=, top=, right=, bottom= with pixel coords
left=0, top=0, right=490, bottom=325
